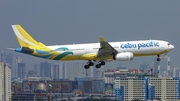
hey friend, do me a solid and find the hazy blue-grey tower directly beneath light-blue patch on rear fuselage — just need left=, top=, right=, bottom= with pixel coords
left=40, top=61, right=51, bottom=78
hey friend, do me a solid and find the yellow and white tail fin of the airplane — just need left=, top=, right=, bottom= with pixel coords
left=12, top=25, right=45, bottom=47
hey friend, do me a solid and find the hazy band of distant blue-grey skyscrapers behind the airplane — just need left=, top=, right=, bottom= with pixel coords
left=1, top=52, right=180, bottom=80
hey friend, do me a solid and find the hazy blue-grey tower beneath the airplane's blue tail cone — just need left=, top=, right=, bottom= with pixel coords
left=17, top=63, right=27, bottom=79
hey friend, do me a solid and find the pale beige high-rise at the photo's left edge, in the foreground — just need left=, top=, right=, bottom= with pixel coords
left=0, top=62, right=11, bottom=101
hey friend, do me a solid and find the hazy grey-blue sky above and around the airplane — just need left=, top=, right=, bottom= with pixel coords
left=0, top=0, right=180, bottom=68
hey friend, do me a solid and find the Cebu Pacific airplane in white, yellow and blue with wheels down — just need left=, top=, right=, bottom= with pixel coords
left=12, top=25, right=174, bottom=69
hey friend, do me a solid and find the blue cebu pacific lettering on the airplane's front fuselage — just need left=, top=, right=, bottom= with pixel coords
left=120, top=41, right=159, bottom=49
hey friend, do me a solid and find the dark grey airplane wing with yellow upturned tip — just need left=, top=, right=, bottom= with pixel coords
left=97, top=36, right=118, bottom=57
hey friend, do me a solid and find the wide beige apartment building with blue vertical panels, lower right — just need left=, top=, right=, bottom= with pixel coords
left=114, top=77, right=180, bottom=101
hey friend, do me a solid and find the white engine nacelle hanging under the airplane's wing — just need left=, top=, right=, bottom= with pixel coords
left=113, top=52, right=134, bottom=61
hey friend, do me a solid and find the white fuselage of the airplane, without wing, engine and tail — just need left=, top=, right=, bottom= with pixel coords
left=47, top=40, right=174, bottom=60
